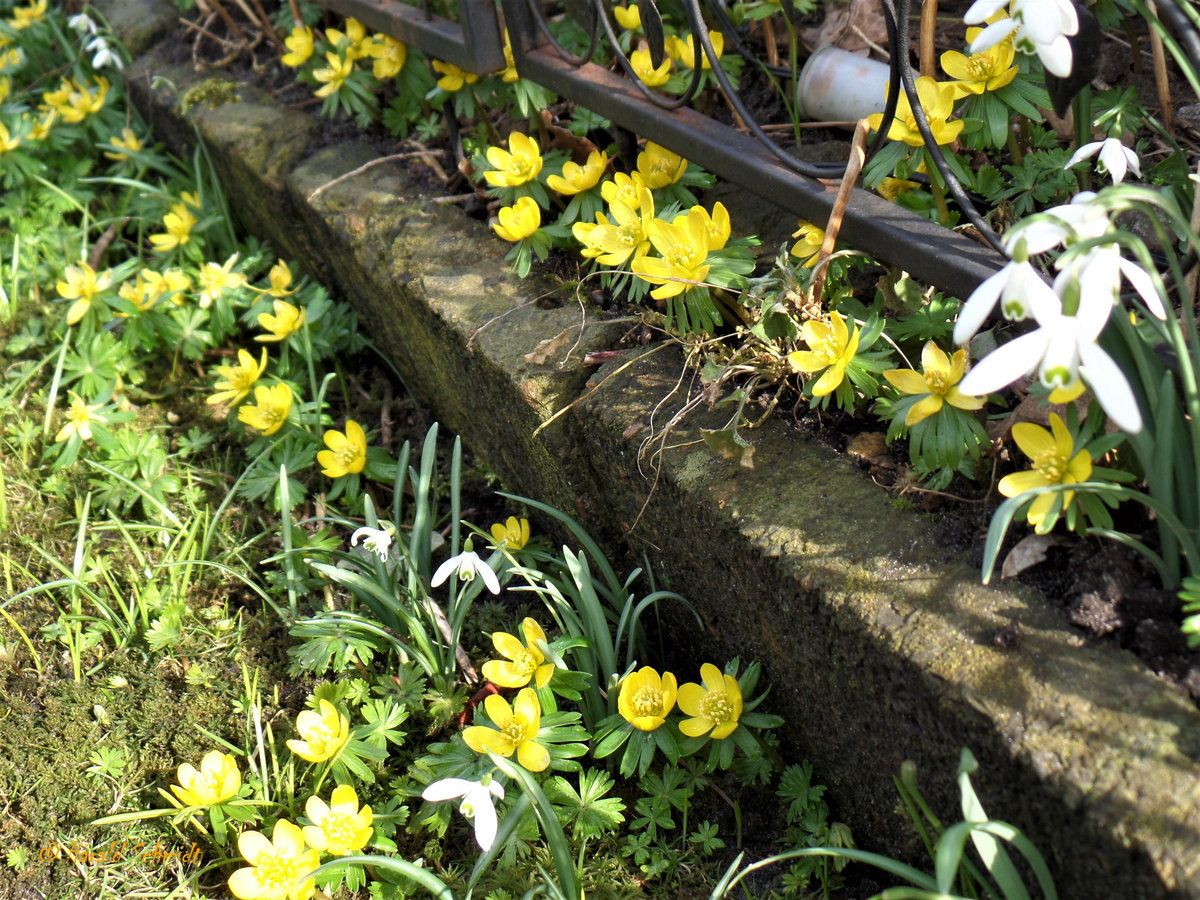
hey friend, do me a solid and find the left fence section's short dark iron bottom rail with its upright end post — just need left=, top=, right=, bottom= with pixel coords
left=322, top=0, right=505, bottom=74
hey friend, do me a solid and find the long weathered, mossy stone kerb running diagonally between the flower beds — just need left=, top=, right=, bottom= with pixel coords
left=127, top=10, right=1200, bottom=900
